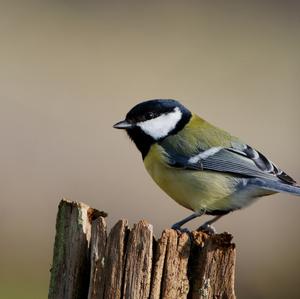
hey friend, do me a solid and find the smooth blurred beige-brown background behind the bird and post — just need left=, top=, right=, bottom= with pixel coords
left=0, top=1, right=300, bottom=299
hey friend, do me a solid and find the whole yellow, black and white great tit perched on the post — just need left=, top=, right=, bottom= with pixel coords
left=114, top=99, right=300, bottom=230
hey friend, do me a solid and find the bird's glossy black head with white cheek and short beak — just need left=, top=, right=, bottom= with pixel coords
left=114, top=100, right=191, bottom=157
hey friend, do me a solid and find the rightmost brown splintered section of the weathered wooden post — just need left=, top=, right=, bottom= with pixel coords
left=189, top=232, right=236, bottom=299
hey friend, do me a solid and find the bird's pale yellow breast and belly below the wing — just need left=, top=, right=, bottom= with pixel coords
left=144, top=144, right=237, bottom=211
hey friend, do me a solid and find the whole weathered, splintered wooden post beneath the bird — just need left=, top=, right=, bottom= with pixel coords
left=48, top=200, right=236, bottom=299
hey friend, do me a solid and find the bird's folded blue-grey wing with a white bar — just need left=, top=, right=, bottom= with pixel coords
left=165, top=143, right=296, bottom=184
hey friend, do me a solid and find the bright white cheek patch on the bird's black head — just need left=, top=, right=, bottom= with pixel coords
left=137, top=107, right=182, bottom=140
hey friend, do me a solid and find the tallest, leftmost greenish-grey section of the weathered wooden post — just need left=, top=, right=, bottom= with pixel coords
left=48, top=199, right=93, bottom=299
